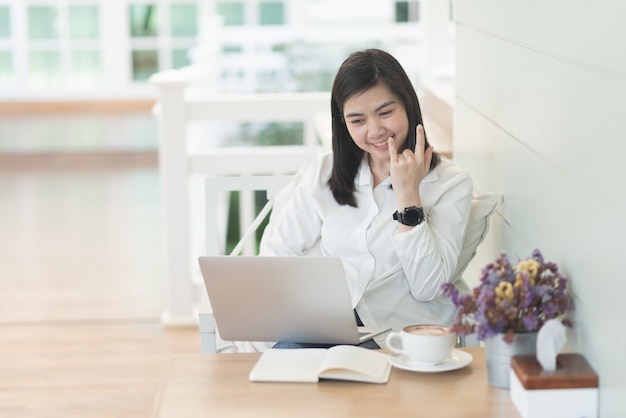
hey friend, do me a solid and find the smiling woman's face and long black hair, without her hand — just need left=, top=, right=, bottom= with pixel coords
left=330, top=49, right=439, bottom=206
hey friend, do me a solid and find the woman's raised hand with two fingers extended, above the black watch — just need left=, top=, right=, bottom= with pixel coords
left=387, top=125, right=433, bottom=210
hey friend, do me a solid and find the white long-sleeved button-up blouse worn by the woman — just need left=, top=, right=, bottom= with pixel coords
left=260, top=154, right=473, bottom=347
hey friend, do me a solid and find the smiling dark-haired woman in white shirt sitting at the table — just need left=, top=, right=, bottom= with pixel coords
left=261, top=49, right=472, bottom=347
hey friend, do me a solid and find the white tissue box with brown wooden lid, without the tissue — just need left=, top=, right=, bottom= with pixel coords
left=510, top=353, right=598, bottom=418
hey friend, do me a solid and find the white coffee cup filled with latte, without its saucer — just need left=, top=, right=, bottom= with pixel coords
left=387, top=324, right=456, bottom=365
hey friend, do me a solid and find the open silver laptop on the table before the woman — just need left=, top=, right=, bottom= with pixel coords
left=198, top=256, right=390, bottom=344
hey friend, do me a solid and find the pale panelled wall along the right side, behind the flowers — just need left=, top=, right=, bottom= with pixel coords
left=454, top=0, right=626, bottom=417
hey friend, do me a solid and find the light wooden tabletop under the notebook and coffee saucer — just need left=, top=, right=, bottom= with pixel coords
left=153, top=347, right=519, bottom=418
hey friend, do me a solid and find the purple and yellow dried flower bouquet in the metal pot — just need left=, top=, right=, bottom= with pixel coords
left=443, top=249, right=574, bottom=343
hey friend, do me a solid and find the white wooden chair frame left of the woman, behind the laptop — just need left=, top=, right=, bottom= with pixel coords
left=198, top=175, right=294, bottom=353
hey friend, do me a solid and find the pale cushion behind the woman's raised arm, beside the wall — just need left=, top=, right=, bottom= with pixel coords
left=451, top=193, right=503, bottom=282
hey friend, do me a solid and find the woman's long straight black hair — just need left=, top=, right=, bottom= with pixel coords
left=328, top=49, right=440, bottom=207
